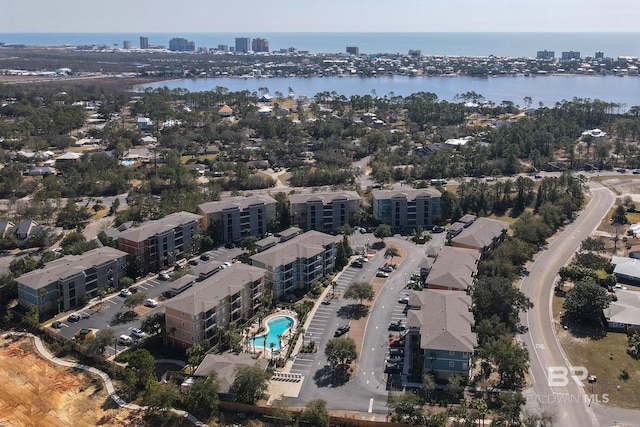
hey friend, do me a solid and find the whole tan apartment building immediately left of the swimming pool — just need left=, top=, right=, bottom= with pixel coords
left=164, top=263, right=266, bottom=348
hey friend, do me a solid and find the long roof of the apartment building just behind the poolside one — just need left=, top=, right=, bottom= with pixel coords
left=251, top=230, right=340, bottom=267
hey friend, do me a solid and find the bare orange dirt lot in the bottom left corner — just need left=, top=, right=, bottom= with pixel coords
left=0, top=338, right=140, bottom=427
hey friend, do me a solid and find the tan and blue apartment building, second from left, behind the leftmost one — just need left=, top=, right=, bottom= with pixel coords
left=118, top=211, right=202, bottom=275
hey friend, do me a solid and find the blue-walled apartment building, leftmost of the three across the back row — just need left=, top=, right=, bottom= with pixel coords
left=198, top=195, right=277, bottom=242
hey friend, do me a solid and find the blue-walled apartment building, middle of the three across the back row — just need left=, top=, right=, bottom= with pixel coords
left=289, top=191, right=360, bottom=232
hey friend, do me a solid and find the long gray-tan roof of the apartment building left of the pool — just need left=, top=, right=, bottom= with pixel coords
left=165, top=263, right=266, bottom=315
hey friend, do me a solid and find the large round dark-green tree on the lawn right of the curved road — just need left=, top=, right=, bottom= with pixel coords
left=563, top=278, right=611, bottom=324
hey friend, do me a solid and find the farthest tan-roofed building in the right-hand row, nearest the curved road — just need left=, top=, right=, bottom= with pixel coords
left=451, top=218, right=509, bottom=258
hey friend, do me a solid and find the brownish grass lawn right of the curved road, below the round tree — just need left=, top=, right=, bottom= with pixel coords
left=553, top=297, right=640, bottom=409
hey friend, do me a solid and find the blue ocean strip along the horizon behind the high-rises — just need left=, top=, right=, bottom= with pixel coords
left=0, top=32, right=640, bottom=58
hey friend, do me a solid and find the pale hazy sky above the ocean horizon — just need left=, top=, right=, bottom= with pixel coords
left=0, top=0, right=640, bottom=33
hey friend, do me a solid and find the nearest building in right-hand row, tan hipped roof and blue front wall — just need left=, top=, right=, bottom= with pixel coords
left=404, top=289, right=478, bottom=379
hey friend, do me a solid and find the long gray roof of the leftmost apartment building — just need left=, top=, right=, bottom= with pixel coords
left=16, top=246, right=127, bottom=289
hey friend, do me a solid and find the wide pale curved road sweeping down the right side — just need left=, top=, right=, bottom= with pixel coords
left=520, top=183, right=640, bottom=427
